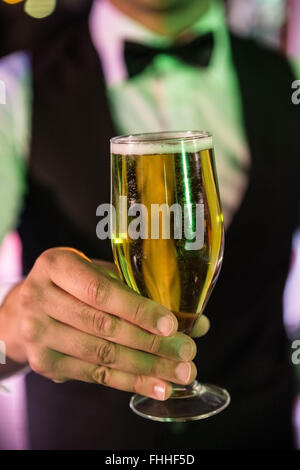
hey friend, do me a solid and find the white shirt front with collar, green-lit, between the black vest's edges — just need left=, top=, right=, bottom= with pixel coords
left=90, top=0, right=250, bottom=226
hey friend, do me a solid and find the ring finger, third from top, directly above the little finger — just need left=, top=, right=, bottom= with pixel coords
left=44, top=321, right=196, bottom=384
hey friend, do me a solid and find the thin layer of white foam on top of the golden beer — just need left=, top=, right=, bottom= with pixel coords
left=110, top=133, right=213, bottom=155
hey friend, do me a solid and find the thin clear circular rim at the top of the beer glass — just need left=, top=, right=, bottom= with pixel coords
left=110, top=131, right=212, bottom=145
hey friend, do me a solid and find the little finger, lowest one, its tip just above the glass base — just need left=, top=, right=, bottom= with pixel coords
left=42, top=353, right=172, bottom=400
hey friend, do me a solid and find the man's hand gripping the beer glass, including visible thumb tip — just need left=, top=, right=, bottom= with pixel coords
left=0, top=248, right=208, bottom=400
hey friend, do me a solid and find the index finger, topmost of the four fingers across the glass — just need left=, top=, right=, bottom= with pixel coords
left=40, top=248, right=178, bottom=336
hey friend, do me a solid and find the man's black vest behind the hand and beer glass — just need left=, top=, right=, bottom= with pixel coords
left=19, top=23, right=300, bottom=449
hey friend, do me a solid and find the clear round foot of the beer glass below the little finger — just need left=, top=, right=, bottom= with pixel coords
left=130, top=380, right=230, bottom=423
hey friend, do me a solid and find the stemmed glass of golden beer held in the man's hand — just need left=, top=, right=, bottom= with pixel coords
left=111, top=131, right=230, bottom=422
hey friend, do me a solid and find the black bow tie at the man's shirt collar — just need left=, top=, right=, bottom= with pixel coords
left=124, top=33, right=214, bottom=78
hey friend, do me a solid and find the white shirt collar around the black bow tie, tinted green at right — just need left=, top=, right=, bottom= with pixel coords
left=89, top=0, right=229, bottom=86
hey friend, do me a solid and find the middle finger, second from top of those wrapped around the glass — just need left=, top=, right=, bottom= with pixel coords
left=43, top=285, right=196, bottom=361
